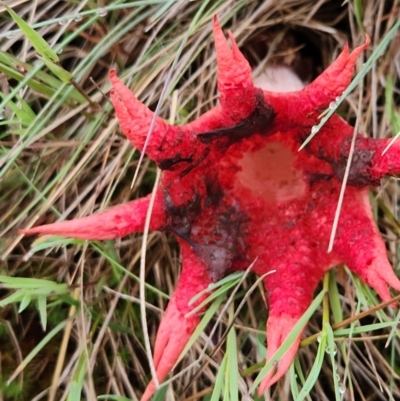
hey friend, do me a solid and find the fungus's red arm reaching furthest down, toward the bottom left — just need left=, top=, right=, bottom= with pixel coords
left=141, top=240, right=211, bottom=401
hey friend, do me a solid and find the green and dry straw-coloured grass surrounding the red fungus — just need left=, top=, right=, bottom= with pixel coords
left=0, top=0, right=400, bottom=401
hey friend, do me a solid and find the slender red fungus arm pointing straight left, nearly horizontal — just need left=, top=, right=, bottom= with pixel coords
left=20, top=191, right=165, bottom=240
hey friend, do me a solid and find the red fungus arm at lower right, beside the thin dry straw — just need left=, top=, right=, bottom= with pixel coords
left=334, top=187, right=400, bottom=301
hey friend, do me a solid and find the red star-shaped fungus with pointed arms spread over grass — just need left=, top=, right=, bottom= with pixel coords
left=22, top=14, right=400, bottom=400
